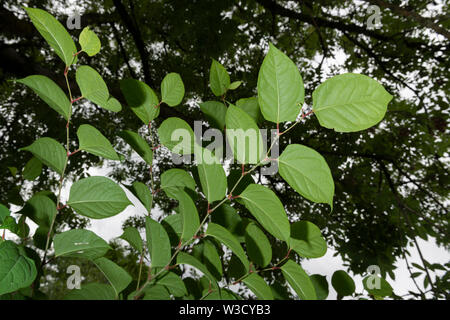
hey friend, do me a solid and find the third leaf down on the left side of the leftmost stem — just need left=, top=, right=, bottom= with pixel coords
left=19, top=138, right=67, bottom=175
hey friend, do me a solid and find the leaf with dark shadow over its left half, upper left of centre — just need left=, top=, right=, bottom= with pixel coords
left=120, top=79, right=159, bottom=125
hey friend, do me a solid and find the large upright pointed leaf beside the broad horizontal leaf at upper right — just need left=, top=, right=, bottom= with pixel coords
left=258, top=44, right=305, bottom=123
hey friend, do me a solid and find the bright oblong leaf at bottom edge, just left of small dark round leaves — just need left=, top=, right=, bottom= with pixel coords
left=281, top=260, right=317, bottom=300
